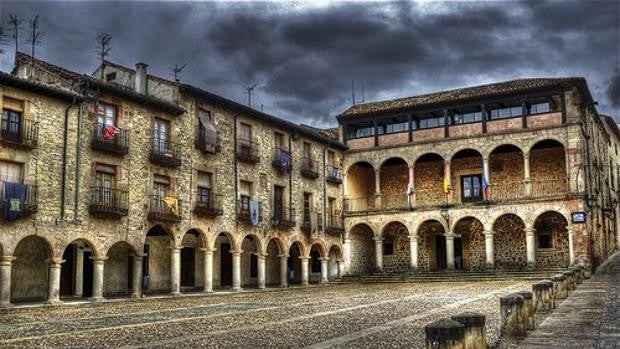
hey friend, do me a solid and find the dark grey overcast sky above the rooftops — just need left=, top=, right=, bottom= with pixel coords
left=0, top=0, right=620, bottom=127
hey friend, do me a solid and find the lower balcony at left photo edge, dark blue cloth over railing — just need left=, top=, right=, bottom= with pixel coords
left=0, top=181, right=37, bottom=221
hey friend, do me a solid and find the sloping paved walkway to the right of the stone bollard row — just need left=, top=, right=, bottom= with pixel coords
left=519, top=252, right=620, bottom=349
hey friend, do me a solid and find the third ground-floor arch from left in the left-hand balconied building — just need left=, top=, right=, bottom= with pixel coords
left=103, top=241, right=135, bottom=297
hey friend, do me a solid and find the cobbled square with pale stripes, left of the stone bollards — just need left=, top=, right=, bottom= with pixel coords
left=0, top=281, right=532, bottom=348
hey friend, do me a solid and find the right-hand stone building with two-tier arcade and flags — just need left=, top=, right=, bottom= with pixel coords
left=338, top=78, right=619, bottom=273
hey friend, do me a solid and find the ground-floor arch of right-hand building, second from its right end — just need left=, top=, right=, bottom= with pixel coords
left=492, top=213, right=527, bottom=270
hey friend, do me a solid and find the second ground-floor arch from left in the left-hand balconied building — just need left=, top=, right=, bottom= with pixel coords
left=59, top=238, right=101, bottom=297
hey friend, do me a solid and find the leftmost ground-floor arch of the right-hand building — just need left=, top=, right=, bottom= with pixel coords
left=349, top=223, right=376, bottom=275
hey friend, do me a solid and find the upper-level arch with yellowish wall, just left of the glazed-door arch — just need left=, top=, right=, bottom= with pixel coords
left=413, top=153, right=446, bottom=207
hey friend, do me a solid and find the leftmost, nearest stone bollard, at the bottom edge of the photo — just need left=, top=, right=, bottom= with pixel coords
left=424, top=319, right=465, bottom=349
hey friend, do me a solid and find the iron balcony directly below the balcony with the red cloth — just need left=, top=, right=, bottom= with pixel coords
left=88, top=186, right=129, bottom=219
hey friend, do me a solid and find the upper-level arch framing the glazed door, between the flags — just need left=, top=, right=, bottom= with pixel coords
left=450, top=149, right=484, bottom=202
